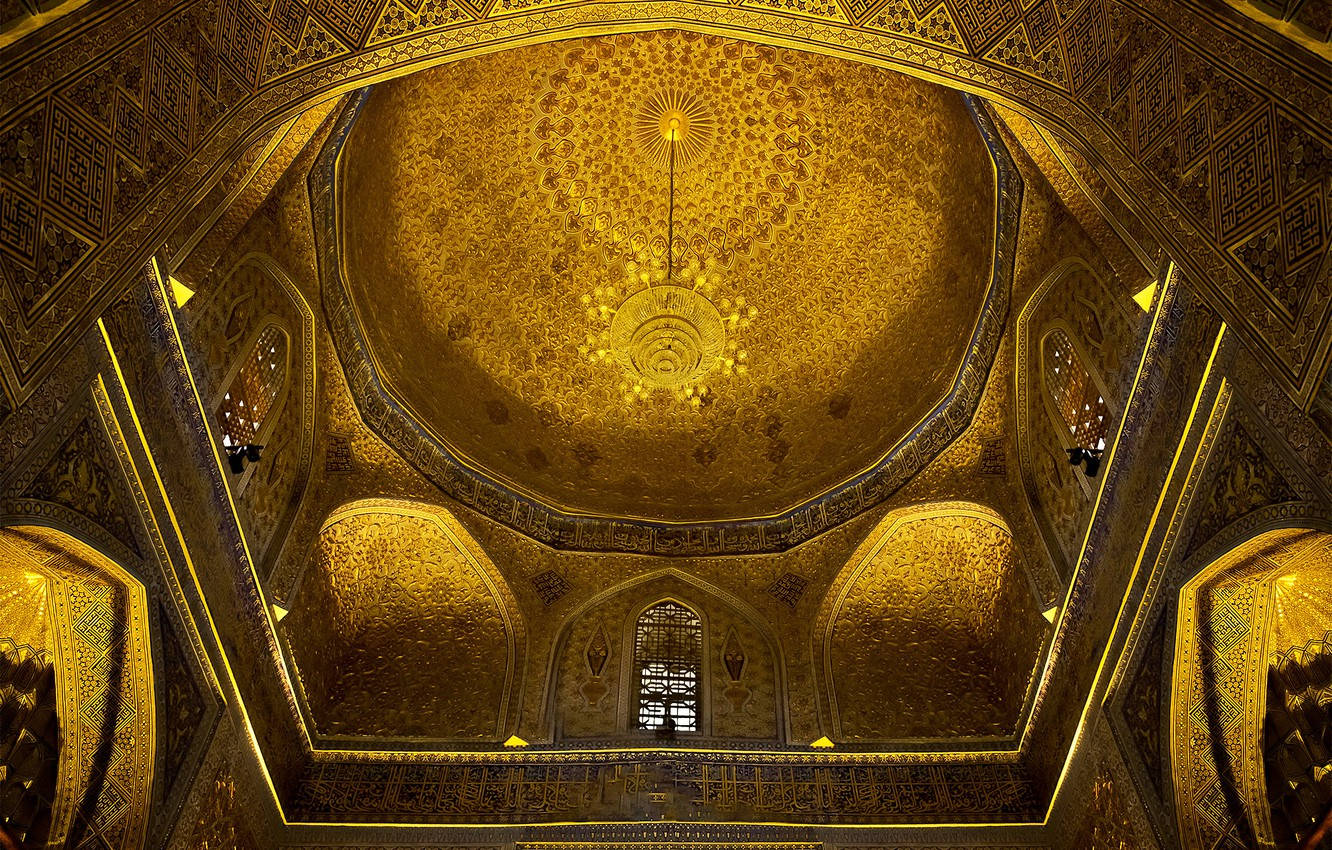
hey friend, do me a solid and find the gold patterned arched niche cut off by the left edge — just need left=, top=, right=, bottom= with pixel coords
left=0, top=526, right=156, bottom=850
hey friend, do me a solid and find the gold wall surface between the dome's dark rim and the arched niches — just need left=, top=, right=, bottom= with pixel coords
left=237, top=81, right=1124, bottom=742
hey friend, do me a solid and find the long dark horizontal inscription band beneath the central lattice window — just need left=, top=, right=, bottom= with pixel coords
left=294, top=753, right=1042, bottom=823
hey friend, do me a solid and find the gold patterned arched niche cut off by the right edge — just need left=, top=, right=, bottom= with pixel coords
left=1169, top=528, right=1332, bottom=850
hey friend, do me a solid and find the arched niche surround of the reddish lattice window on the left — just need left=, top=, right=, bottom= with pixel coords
left=181, top=253, right=316, bottom=574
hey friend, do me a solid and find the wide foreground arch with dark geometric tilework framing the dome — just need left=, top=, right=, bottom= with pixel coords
left=0, top=0, right=1332, bottom=410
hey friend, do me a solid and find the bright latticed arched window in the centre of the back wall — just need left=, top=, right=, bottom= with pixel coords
left=634, top=602, right=703, bottom=731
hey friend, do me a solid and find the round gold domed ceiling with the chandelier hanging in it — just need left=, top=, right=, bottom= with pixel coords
left=327, top=31, right=996, bottom=522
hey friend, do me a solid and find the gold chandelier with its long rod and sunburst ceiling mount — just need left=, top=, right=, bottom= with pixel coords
left=579, top=92, right=758, bottom=408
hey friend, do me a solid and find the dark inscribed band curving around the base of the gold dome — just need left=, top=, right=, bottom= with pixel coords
left=309, top=89, right=1023, bottom=557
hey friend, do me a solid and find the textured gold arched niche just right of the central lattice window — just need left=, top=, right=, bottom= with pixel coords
left=814, top=502, right=1048, bottom=742
